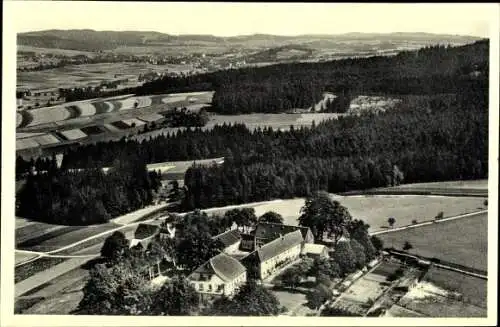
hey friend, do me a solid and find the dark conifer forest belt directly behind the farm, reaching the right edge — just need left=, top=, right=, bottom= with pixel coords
left=18, top=89, right=488, bottom=209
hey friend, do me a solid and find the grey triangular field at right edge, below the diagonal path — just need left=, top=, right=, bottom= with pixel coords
left=379, top=213, right=488, bottom=270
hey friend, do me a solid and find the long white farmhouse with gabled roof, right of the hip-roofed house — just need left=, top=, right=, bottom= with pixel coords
left=242, top=230, right=304, bottom=279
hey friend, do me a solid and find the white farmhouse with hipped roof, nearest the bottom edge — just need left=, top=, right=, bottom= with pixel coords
left=187, top=253, right=247, bottom=297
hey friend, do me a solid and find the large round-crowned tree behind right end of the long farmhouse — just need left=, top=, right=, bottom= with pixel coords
left=298, top=191, right=352, bottom=243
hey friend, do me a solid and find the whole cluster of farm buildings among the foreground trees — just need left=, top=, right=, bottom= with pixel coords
left=131, top=221, right=328, bottom=298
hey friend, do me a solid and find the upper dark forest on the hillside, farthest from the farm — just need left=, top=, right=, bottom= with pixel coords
left=136, top=41, right=489, bottom=114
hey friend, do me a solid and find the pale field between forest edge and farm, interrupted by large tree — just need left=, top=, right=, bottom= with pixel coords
left=249, top=195, right=484, bottom=232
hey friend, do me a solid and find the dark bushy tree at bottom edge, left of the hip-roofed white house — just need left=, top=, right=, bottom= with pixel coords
left=152, top=276, right=200, bottom=316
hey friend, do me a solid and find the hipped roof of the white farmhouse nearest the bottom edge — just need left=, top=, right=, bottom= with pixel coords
left=188, top=253, right=246, bottom=282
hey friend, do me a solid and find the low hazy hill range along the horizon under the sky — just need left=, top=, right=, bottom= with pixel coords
left=17, top=29, right=480, bottom=51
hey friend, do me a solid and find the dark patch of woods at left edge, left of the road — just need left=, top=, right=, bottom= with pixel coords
left=16, top=160, right=160, bottom=225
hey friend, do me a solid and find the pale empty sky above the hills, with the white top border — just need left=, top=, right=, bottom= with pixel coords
left=4, top=0, right=498, bottom=37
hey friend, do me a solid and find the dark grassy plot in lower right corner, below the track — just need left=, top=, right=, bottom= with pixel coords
left=424, top=267, right=488, bottom=308
